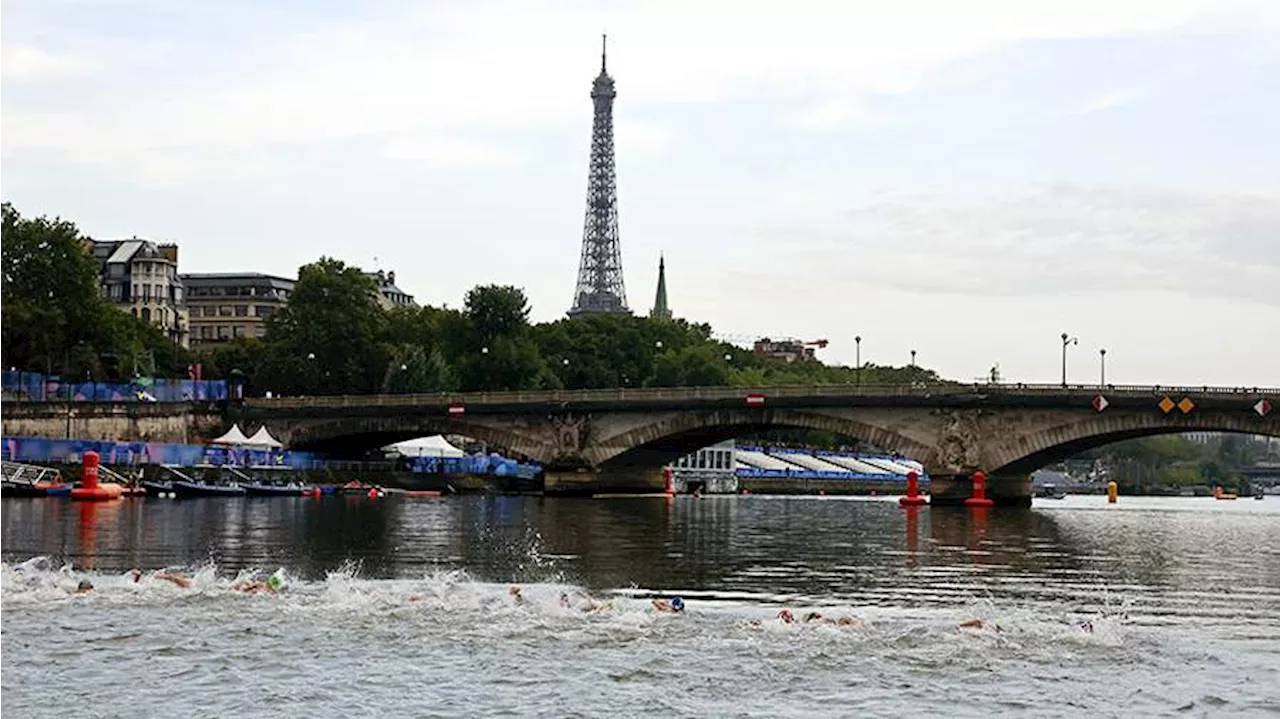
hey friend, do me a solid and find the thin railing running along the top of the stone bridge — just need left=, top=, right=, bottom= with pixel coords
left=244, top=383, right=1280, bottom=409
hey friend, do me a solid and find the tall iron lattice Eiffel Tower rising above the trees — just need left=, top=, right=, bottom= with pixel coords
left=568, top=38, right=631, bottom=317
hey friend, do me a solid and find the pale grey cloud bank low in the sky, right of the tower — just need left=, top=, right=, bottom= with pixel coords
left=752, top=184, right=1280, bottom=304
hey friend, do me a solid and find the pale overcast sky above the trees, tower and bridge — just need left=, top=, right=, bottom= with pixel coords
left=0, top=0, right=1280, bottom=386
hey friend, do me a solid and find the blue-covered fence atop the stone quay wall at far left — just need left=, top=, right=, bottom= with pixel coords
left=0, top=370, right=229, bottom=402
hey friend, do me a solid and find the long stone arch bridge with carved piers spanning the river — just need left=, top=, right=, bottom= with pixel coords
left=228, top=385, right=1280, bottom=504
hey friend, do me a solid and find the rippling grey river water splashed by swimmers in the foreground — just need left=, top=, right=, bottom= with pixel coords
left=0, top=496, right=1280, bottom=718
